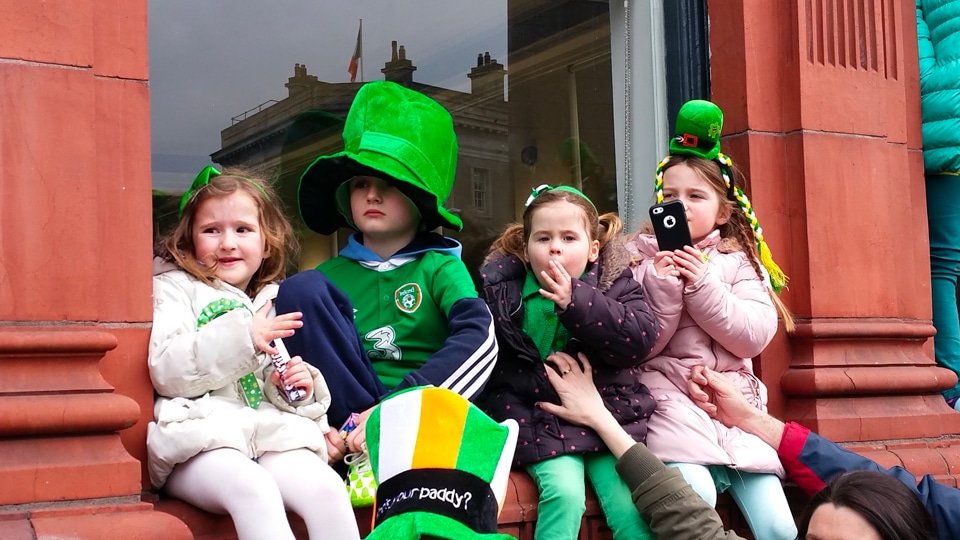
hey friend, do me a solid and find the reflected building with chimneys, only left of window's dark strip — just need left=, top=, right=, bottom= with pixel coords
left=211, top=42, right=514, bottom=267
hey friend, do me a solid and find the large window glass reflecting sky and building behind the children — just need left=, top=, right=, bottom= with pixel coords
left=150, top=0, right=617, bottom=278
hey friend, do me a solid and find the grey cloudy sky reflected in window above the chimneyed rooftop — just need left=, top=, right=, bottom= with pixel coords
left=149, top=0, right=507, bottom=191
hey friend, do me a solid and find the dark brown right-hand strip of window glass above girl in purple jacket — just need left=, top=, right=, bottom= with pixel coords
left=507, top=0, right=617, bottom=212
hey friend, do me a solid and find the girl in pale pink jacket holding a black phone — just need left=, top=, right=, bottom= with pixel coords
left=628, top=100, right=797, bottom=540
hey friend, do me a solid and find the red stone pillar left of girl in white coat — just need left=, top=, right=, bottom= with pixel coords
left=0, top=0, right=189, bottom=539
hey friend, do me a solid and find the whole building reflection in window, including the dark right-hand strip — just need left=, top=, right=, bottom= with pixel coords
left=212, top=0, right=617, bottom=270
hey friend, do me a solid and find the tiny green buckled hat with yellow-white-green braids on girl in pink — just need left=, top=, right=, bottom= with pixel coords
left=653, top=99, right=789, bottom=293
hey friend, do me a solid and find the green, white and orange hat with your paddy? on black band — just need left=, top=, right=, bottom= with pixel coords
left=366, top=386, right=519, bottom=540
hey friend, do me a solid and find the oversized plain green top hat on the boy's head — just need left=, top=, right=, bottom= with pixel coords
left=298, top=81, right=463, bottom=234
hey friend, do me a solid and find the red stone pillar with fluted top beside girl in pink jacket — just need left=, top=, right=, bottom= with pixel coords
left=708, top=0, right=960, bottom=476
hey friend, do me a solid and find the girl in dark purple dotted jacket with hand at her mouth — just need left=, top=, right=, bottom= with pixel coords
left=478, top=186, right=656, bottom=540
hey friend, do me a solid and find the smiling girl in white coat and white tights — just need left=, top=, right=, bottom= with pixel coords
left=147, top=167, right=359, bottom=539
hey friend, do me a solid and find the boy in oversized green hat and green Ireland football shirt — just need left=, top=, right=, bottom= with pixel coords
left=277, top=81, right=497, bottom=468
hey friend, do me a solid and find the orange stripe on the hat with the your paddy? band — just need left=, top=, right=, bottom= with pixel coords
left=411, top=388, right=470, bottom=469
